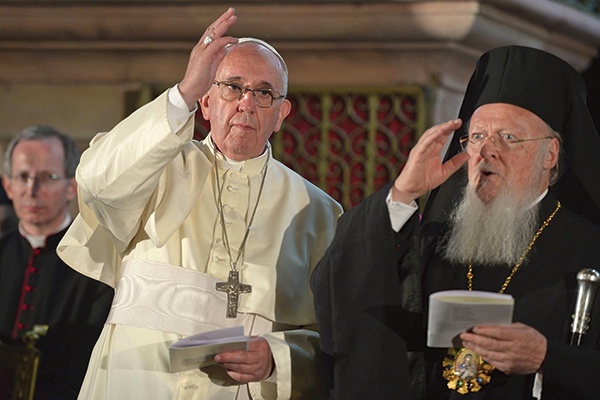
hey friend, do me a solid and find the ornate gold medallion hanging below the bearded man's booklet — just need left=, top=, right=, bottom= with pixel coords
left=442, top=347, right=495, bottom=394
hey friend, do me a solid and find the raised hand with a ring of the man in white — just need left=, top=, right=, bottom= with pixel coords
left=179, top=8, right=238, bottom=110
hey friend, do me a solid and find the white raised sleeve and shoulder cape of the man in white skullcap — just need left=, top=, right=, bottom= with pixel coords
left=58, top=92, right=210, bottom=287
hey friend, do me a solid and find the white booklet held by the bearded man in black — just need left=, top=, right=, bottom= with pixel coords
left=427, top=290, right=514, bottom=348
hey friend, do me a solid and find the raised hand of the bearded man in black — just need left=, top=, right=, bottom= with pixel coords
left=392, top=119, right=469, bottom=204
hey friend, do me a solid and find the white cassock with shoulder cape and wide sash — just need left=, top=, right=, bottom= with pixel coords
left=58, top=92, right=342, bottom=400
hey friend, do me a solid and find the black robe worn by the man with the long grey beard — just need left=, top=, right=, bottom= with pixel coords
left=312, top=185, right=600, bottom=400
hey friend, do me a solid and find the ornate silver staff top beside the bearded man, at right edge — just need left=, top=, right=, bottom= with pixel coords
left=571, top=268, right=600, bottom=346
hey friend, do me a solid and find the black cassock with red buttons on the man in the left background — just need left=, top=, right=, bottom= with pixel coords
left=0, top=229, right=113, bottom=399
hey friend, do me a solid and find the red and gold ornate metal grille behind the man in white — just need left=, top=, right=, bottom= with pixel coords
left=196, top=87, right=426, bottom=209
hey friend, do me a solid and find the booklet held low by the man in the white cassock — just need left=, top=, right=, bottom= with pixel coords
left=169, top=326, right=249, bottom=372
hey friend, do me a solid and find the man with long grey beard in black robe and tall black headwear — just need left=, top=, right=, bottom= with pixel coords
left=311, top=46, right=600, bottom=400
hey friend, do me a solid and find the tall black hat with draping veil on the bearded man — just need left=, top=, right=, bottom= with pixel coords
left=424, top=46, right=600, bottom=224
